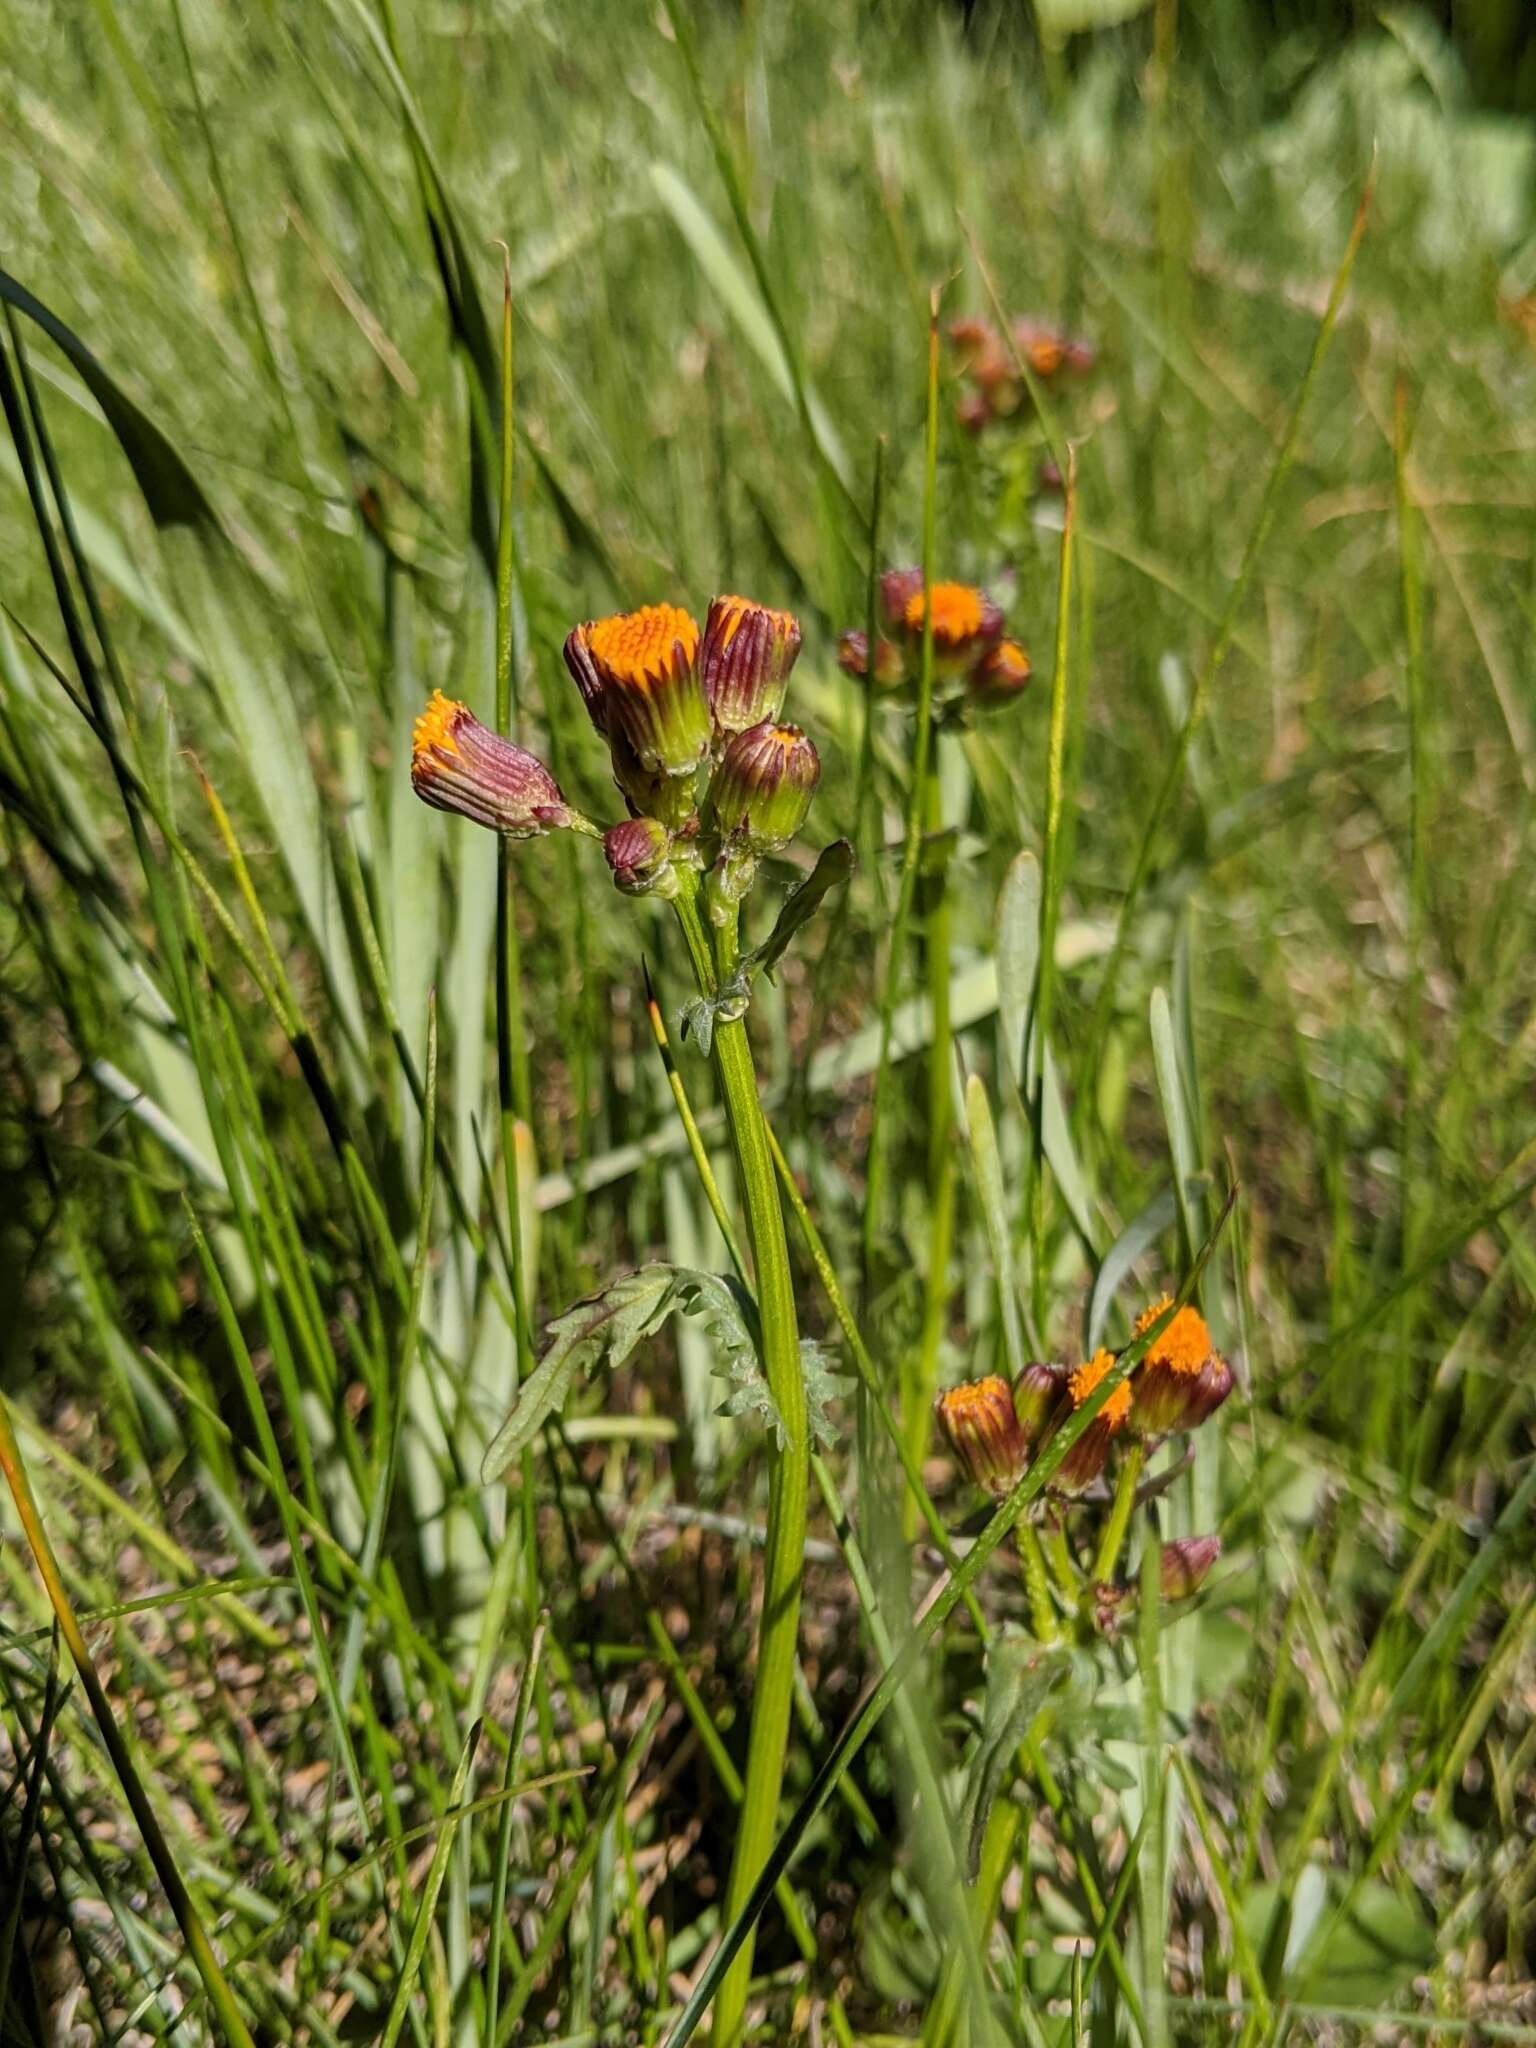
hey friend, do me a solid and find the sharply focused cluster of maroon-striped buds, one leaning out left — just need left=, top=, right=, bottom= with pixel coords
left=412, top=596, right=821, bottom=901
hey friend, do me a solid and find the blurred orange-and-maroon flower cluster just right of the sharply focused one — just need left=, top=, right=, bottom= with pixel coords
left=838, top=569, right=1030, bottom=715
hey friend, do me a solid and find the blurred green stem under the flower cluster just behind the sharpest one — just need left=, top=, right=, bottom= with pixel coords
left=901, top=741, right=954, bottom=1542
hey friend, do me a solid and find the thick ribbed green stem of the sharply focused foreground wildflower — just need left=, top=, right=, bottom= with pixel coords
left=676, top=883, right=809, bottom=2048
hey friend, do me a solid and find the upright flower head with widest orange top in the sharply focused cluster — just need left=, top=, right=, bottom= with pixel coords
left=565, top=604, right=709, bottom=776
